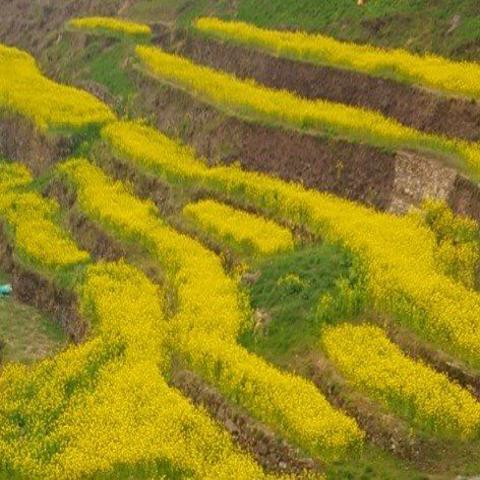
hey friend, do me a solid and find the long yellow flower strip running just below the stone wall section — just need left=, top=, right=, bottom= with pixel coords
left=102, top=122, right=480, bottom=366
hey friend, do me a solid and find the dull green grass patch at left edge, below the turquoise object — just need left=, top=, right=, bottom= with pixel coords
left=0, top=272, right=67, bottom=364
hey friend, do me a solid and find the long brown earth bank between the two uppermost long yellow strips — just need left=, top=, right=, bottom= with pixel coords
left=156, top=25, right=480, bottom=140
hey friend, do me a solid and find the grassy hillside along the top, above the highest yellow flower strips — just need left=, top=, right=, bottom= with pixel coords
left=0, top=0, right=480, bottom=59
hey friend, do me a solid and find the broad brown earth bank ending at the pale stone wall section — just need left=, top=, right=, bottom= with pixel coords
left=135, top=73, right=395, bottom=209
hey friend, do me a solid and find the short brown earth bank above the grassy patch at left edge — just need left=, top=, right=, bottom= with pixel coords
left=0, top=225, right=87, bottom=343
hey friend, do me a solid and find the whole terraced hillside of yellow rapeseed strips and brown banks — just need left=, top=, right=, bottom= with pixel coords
left=0, top=2, right=480, bottom=480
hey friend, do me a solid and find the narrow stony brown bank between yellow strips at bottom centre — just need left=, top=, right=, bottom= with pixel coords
left=171, top=370, right=320, bottom=474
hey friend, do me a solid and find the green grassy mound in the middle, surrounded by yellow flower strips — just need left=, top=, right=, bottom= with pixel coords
left=242, top=243, right=352, bottom=363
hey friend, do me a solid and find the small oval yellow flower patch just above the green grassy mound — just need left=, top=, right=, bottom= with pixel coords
left=183, top=200, right=294, bottom=255
